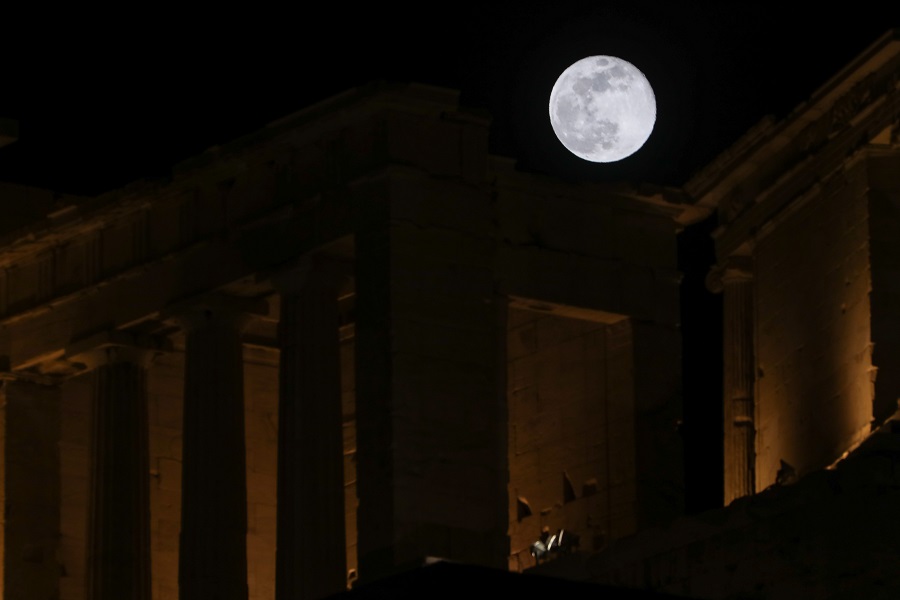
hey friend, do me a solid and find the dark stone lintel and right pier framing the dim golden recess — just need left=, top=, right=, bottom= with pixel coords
left=494, top=162, right=684, bottom=528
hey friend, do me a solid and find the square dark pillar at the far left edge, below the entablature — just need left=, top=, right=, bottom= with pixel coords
left=0, top=379, right=60, bottom=598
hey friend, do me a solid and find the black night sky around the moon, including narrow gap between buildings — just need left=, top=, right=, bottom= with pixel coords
left=0, top=0, right=900, bottom=511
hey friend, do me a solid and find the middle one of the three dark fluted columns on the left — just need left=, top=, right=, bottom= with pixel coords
left=178, top=302, right=248, bottom=600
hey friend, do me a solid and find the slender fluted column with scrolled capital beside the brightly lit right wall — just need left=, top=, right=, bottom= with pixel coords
left=710, top=256, right=756, bottom=506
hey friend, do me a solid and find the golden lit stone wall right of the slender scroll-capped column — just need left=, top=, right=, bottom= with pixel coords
left=755, top=159, right=873, bottom=490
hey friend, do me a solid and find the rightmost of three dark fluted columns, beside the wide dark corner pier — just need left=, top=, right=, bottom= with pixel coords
left=274, top=259, right=347, bottom=600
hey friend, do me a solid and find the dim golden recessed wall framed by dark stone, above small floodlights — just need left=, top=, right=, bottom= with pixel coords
left=507, top=308, right=636, bottom=571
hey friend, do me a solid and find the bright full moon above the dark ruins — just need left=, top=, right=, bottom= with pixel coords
left=550, top=56, right=656, bottom=162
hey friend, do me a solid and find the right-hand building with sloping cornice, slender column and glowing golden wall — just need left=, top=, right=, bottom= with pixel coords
left=686, top=33, right=900, bottom=504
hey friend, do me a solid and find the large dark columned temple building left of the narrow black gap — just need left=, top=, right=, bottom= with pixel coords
left=0, top=80, right=704, bottom=600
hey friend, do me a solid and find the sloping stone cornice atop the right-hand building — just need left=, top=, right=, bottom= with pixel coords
left=685, top=29, right=900, bottom=258
